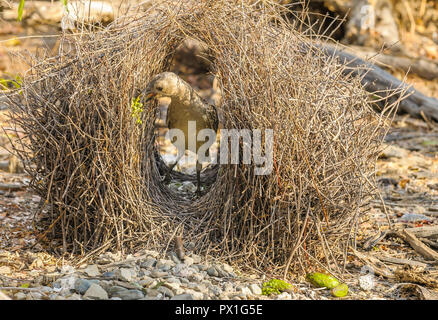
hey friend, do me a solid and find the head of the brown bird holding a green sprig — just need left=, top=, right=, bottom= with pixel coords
left=146, top=72, right=180, bottom=101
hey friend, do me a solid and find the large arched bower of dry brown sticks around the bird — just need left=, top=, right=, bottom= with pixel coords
left=4, top=0, right=397, bottom=277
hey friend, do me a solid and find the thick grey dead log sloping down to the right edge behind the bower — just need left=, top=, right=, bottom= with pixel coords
left=318, top=44, right=438, bottom=121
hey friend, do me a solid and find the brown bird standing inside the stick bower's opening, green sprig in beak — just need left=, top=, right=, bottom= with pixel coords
left=146, top=72, right=219, bottom=195
